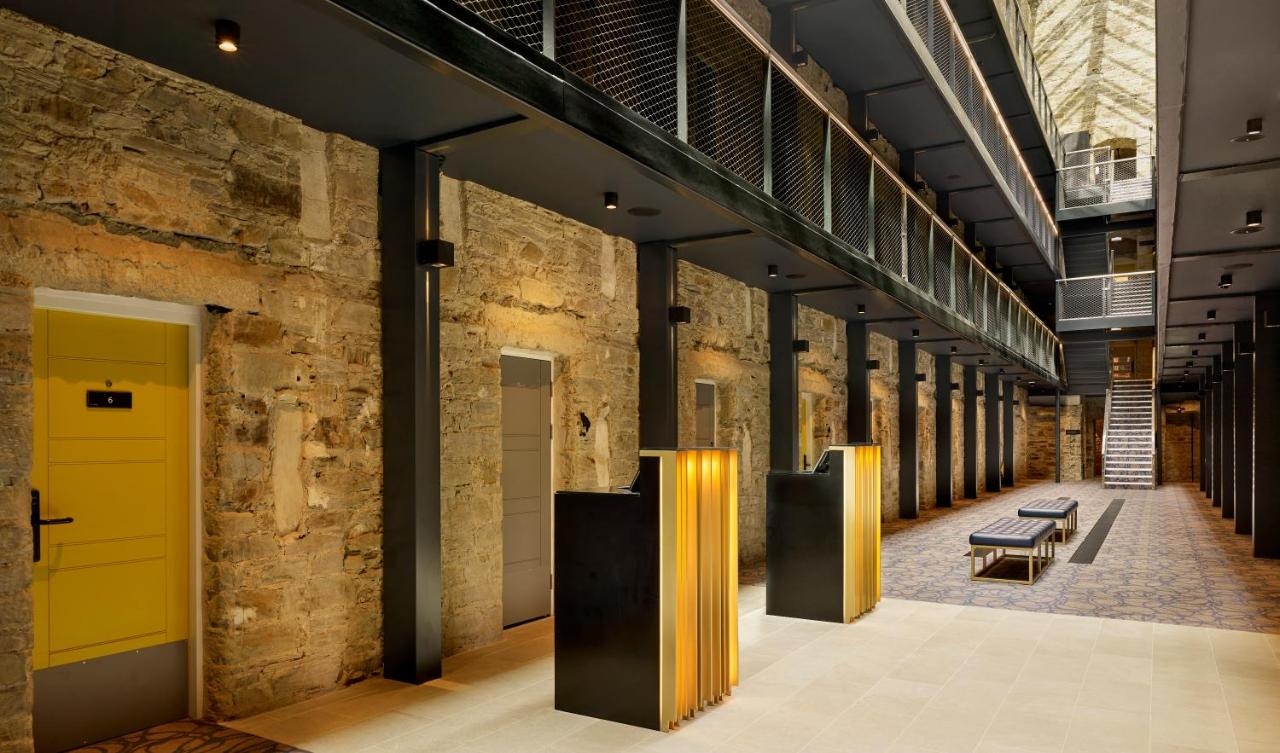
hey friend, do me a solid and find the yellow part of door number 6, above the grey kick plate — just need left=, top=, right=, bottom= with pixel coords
left=32, top=310, right=189, bottom=665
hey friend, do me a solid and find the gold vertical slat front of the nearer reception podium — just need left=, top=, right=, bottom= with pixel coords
left=641, top=448, right=739, bottom=729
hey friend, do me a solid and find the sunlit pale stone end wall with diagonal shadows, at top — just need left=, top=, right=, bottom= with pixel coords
left=1033, top=0, right=1156, bottom=144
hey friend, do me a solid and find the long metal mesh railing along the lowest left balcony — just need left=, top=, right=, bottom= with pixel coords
left=450, top=0, right=1057, bottom=377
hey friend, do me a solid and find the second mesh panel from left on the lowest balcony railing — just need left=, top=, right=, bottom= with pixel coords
left=556, top=0, right=680, bottom=133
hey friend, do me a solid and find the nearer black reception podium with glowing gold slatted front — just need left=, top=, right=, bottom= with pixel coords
left=554, top=448, right=737, bottom=730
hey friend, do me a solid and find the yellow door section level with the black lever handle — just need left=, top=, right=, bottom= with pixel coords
left=46, top=462, right=165, bottom=547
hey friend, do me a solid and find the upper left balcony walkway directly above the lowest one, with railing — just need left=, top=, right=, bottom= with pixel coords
left=765, top=0, right=1060, bottom=295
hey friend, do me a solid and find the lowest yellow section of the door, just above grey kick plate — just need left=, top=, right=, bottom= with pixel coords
left=49, top=560, right=165, bottom=663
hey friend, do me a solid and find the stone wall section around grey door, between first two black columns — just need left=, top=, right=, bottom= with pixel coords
left=440, top=178, right=639, bottom=654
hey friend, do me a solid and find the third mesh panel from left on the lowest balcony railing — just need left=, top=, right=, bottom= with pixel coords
left=686, top=0, right=769, bottom=188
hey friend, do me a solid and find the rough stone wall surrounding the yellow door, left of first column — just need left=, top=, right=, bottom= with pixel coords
left=0, top=12, right=381, bottom=722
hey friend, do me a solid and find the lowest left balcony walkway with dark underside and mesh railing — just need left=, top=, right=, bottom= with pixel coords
left=0, top=0, right=1060, bottom=384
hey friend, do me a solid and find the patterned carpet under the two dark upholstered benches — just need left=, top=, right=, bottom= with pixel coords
left=883, top=482, right=1280, bottom=633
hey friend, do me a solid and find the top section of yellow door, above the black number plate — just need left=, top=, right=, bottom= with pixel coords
left=49, top=311, right=166, bottom=364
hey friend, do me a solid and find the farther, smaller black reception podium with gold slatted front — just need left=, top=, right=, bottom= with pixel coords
left=764, top=444, right=881, bottom=622
